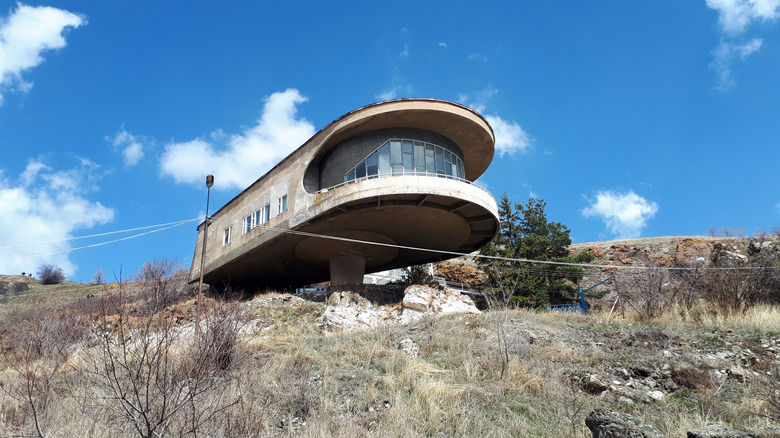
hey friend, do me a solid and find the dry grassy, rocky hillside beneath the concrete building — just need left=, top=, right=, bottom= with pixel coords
left=0, top=238, right=780, bottom=437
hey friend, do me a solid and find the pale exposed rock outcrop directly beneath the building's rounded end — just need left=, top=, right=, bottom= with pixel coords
left=320, top=285, right=480, bottom=330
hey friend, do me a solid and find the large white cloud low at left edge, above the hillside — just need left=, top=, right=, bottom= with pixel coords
left=0, top=160, right=114, bottom=276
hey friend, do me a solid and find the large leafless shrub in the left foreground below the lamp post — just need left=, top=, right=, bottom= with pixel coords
left=79, top=285, right=240, bottom=438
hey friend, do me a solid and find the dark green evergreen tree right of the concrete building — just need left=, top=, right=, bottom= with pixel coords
left=480, top=193, right=589, bottom=307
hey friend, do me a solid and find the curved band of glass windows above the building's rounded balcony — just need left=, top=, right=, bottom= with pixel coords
left=344, top=138, right=464, bottom=182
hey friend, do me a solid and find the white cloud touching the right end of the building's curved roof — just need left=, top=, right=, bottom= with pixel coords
left=458, top=87, right=533, bottom=155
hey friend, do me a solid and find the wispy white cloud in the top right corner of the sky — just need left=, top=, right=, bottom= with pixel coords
left=707, top=0, right=780, bottom=91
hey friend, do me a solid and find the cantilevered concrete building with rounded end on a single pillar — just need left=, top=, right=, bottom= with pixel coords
left=190, top=99, right=498, bottom=290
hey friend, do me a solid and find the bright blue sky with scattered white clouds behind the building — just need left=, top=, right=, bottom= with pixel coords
left=0, top=0, right=780, bottom=281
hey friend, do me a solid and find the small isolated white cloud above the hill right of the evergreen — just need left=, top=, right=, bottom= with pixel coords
left=582, top=190, right=658, bottom=239
